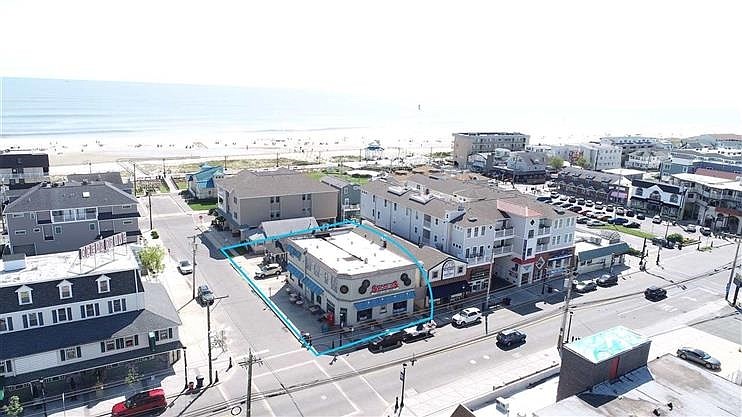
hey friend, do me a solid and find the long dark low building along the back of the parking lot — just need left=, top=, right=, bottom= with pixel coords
left=554, top=167, right=631, bottom=205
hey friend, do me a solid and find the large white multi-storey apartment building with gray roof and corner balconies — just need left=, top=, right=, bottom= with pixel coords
left=361, top=174, right=575, bottom=291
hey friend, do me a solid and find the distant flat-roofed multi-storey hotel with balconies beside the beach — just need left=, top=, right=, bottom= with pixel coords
left=452, top=132, right=530, bottom=168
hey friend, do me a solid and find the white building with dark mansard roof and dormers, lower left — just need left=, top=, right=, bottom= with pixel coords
left=0, top=245, right=182, bottom=401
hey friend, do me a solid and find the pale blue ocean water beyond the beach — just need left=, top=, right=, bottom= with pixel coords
left=0, top=78, right=438, bottom=137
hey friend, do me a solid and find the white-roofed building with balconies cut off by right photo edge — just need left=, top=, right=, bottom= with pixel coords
left=670, top=173, right=742, bottom=234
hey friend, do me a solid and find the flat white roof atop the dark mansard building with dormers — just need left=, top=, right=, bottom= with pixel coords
left=0, top=245, right=139, bottom=287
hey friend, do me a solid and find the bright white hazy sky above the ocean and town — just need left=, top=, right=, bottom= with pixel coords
left=0, top=0, right=742, bottom=133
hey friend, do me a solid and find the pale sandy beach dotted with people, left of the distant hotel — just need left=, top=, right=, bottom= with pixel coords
left=0, top=129, right=453, bottom=175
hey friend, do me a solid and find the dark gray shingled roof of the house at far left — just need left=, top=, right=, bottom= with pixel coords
left=5, top=182, right=138, bottom=213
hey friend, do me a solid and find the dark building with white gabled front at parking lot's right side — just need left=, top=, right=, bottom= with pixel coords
left=629, top=180, right=685, bottom=219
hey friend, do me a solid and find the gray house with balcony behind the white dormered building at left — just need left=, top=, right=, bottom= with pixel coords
left=3, top=182, right=141, bottom=255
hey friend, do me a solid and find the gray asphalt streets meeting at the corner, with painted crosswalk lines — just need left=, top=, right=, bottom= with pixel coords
left=152, top=195, right=739, bottom=416
